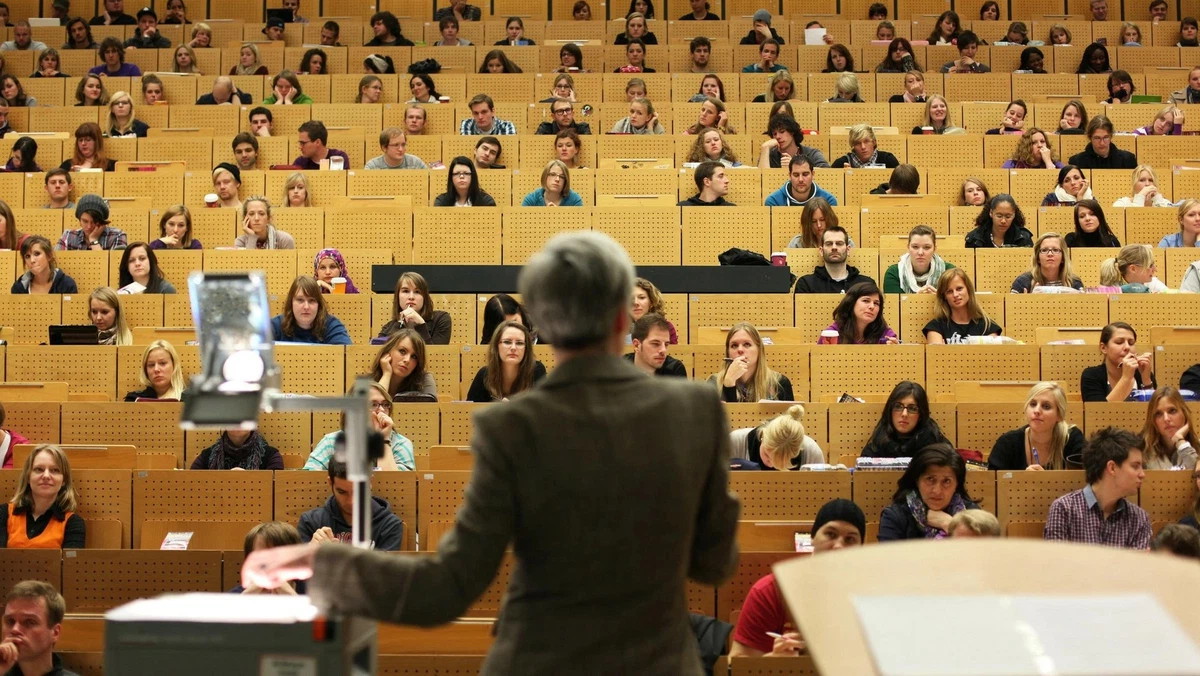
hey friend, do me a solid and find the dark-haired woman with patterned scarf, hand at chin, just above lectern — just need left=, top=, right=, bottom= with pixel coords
left=880, top=443, right=979, bottom=543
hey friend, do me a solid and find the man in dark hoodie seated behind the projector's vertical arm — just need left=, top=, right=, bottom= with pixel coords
left=296, top=460, right=404, bottom=551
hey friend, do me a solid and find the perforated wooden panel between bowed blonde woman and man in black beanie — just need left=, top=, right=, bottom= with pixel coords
left=730, top=472, right=851, bottom=520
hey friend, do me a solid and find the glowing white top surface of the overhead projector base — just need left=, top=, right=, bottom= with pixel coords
left=104, top=593, right=318, bottom=624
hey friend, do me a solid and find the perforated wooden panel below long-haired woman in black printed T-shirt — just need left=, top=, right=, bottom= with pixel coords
left=925, top=345, right=1040, bottom=397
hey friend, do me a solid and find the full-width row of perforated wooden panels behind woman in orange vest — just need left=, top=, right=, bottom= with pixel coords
left=0, top=469, right=1195, bottom=557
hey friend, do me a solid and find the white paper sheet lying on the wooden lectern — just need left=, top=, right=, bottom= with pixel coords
left=851, top=594, right=1200, bottom=676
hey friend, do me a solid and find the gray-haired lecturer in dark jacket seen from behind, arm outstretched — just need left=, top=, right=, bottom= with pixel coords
left=242, top=232, right=738, bottom=676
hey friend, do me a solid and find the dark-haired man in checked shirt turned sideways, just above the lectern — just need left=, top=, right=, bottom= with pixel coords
left=1045, top=427, right=1150, bottom=549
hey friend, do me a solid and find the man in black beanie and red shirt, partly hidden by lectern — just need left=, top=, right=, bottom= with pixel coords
left=730, top=497, right=866, bottom=657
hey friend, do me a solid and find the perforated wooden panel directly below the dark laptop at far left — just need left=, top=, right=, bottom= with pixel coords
left=7, top=345, right=116, bottom=399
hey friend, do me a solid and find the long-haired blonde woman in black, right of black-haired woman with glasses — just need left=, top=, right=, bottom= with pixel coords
left=988, top=382, right=1084, bottom=469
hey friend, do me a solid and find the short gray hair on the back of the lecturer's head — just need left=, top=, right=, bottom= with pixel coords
left=517, top=231, right=634, bottom=348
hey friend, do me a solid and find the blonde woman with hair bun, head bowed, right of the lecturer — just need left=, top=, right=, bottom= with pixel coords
left=730, top=403, right=824, bottom=471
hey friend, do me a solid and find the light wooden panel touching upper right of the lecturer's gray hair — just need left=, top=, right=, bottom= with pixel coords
left=592, top=207, right=683, bottom=265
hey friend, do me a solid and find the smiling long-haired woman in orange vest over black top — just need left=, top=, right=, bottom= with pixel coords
left=0, top=444, right=88, bottom=549
